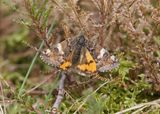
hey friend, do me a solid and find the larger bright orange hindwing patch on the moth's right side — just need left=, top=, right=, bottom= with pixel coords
left=77, top=50, right=97, bottom=72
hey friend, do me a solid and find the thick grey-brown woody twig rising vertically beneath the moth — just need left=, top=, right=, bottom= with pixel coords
left=51, top=72, right=66, bottom=114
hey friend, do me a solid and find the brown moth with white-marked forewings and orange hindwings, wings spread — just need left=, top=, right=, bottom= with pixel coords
left=40, top=34, right=118, bottom=75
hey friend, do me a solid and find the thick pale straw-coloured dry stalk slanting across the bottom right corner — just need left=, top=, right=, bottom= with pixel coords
left=115, top=99, right=160, bottom=114
